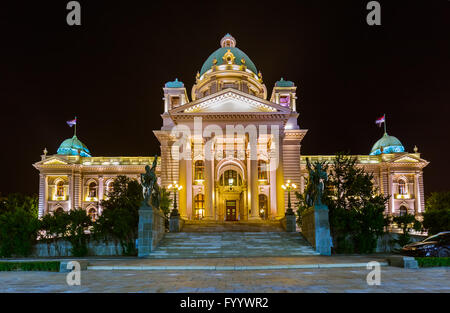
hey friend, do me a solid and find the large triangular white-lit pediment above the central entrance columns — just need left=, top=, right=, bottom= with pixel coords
left=169, top=89, right=290, bottom=114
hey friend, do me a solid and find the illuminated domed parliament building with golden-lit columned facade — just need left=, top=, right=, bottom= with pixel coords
left=34, top=34, right=428, bottom=221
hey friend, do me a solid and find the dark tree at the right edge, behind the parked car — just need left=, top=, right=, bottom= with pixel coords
left=423, top=191, right=450, bottom=235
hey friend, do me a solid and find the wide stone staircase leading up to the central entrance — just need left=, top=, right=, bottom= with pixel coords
left=149, top=222, right=319, bottom=259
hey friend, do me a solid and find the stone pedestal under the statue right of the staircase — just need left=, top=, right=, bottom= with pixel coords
left=302, top=204, right=332, bottom=255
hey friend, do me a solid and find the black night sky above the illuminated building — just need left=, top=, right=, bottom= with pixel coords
left=0, top=0, right=450, bottom=194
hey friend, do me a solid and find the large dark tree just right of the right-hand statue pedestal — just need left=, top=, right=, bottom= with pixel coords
left=324, top=153, right=389, bottom=253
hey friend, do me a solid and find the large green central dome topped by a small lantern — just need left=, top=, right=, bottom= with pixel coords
left=200, top=34, right=258, bottom=76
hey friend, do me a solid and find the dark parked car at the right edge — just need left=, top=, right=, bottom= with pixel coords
left=400, top=231, right=450, bottom=257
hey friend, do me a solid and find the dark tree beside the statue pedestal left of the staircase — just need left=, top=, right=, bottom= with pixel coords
left=94, top=176, right=144, bottom=255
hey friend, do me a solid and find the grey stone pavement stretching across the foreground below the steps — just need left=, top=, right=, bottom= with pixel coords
left=0, top=267, right=450, bottom=293
